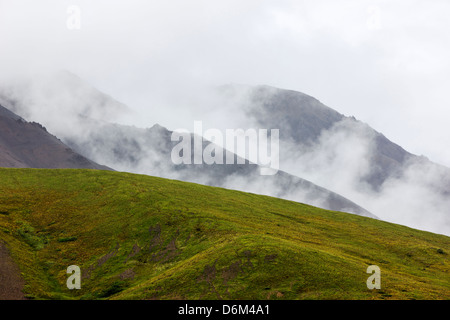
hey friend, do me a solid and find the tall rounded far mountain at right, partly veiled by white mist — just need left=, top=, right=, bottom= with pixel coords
left=216, top=85, right=450, bottom=234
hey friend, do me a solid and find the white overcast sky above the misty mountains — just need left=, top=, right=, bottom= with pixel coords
left=0, top=0, right=450, bottom=166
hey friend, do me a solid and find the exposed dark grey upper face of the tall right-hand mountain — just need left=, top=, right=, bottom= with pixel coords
left=234, top=86, right=416, bottom=190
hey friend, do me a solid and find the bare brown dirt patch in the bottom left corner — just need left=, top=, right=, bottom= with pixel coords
left=0, top=242, right=25, bottom=300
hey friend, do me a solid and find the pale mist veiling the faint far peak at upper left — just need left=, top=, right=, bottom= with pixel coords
left=0, top=70, right=131, bottom=124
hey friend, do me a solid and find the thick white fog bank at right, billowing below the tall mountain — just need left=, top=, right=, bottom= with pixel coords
left=282, top=119, right=450, bottom=235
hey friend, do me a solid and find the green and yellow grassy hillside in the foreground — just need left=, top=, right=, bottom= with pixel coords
left=0, top=169, right=450, bottom=299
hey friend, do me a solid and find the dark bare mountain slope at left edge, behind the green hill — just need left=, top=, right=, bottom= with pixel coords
left=0, top=105, right=111, bottom=170
